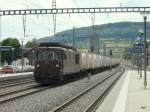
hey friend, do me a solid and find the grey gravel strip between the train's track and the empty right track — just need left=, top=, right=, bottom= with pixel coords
left=0, top=69, right=119, bottom=112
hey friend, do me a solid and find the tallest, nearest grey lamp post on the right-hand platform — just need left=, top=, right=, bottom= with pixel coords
left=141, top=12, right=149, bottom=88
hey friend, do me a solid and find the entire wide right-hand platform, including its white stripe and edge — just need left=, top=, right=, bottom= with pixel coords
left=96, top=70, right=150, bottom=112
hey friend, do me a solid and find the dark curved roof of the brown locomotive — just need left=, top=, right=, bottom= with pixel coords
left=39, top=43, right=76, bottom=51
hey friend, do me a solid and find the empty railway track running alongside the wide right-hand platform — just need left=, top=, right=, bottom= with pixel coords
left=50, top=68, right=124, bottom=112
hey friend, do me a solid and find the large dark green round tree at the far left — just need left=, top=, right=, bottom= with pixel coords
left=1, top=38, right=21, bottom=64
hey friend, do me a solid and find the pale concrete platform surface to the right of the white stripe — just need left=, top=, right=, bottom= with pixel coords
left=126, top=71, right=150, bottom=112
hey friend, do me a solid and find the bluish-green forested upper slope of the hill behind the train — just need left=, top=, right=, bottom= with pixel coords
left=39, top=22, right=150, bottom=42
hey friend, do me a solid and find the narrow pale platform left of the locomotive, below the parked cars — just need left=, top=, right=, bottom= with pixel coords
left=0, top=72, right=33, bottom=81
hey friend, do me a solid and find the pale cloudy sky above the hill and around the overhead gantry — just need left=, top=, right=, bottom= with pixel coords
left=0, top=0, right=150, bottom=41
